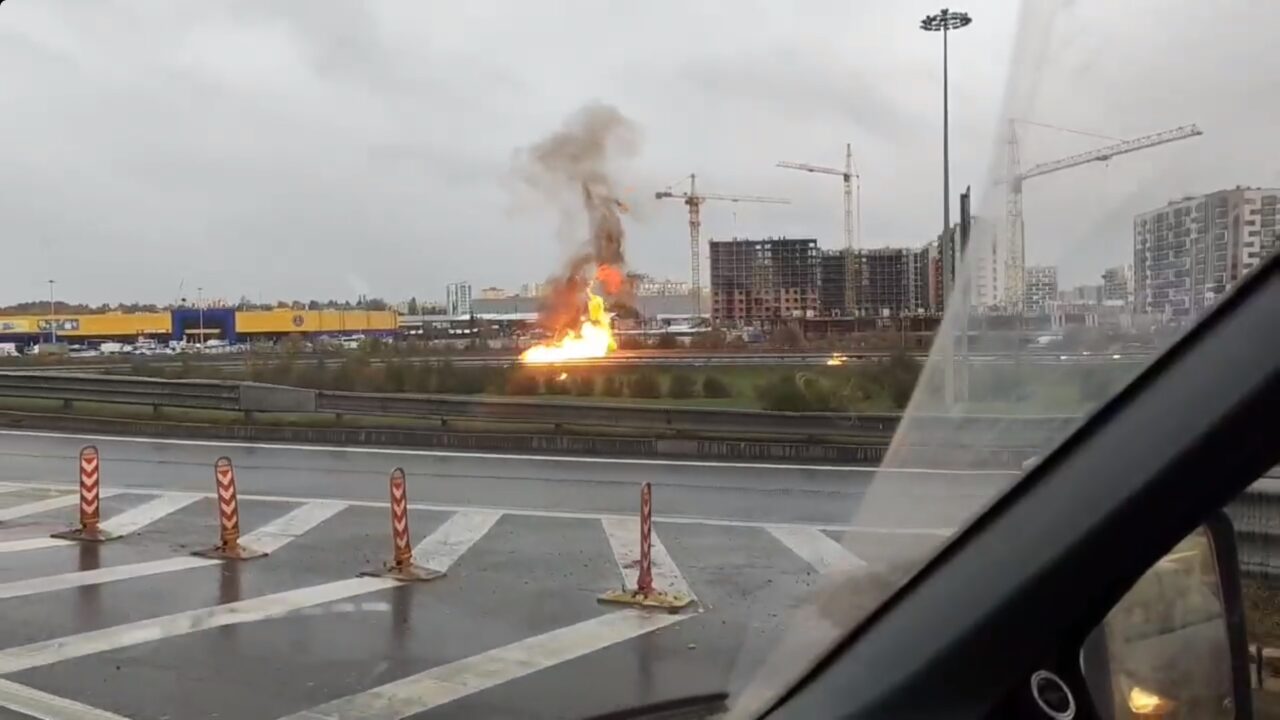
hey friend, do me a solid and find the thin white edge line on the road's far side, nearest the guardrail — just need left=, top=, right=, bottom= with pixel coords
left=0, top=430, right=1021, bottom=477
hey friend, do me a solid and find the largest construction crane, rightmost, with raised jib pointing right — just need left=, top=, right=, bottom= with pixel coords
left=1005, top=120, right=1204, bottom=314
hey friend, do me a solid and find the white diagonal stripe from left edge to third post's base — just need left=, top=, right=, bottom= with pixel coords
left=0, top=578, right=399, bottom=675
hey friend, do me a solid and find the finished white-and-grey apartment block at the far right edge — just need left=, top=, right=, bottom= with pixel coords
left=1133, top=187, right=1280, bottom=320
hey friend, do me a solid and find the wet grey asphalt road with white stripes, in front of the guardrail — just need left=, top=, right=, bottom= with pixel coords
left=0, top=433, right=1007, bottom=720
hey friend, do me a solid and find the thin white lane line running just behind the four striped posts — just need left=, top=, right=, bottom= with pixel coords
left=0, top=483, right=955, bottom=537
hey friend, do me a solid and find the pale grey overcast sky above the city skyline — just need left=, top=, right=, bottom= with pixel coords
left=0, top=0, right=1280, bottom=302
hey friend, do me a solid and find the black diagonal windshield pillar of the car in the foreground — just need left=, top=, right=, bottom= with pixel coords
left=765, top=255, right=1280, bottom=717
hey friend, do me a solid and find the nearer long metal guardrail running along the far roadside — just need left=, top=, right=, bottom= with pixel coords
left=0, top=373, right=1079, bottom=450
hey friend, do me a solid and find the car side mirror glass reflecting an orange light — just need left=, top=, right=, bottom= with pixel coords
left=1080, top=512, right=1253, bottom=720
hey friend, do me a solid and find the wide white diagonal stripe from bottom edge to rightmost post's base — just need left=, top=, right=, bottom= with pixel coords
left=282, top=610, right=690, bottom=720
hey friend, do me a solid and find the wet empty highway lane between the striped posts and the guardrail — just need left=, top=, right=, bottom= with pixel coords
left=0, top=425, right=1010, bottom=528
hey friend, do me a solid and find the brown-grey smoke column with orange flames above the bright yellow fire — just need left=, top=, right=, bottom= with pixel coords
left=516, top=102, right=639, bottom=333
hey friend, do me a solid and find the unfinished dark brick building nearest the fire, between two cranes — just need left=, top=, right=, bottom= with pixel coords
left=709, top=237, right=822, bottom=324
